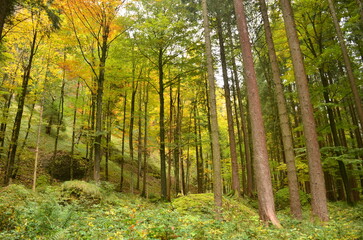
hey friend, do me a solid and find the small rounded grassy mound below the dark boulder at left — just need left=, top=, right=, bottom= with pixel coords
left=62, top=180, right=102, bottom=205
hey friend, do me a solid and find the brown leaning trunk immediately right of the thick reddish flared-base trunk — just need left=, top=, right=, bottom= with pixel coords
left=260, top=0, right=302, bottom=219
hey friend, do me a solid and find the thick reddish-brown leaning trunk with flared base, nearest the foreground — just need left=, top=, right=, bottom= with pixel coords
left=234, top=0, right=281, bottom=227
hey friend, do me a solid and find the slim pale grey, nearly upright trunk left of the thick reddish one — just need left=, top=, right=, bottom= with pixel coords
left=202, top=0, right=222, bottom=212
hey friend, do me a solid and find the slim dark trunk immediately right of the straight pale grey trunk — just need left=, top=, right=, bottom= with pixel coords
left=217, top=13, right=241, bottom=196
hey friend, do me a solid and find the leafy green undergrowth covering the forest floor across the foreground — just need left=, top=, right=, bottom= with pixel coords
left=0, top=181, right=363, bottom=240
